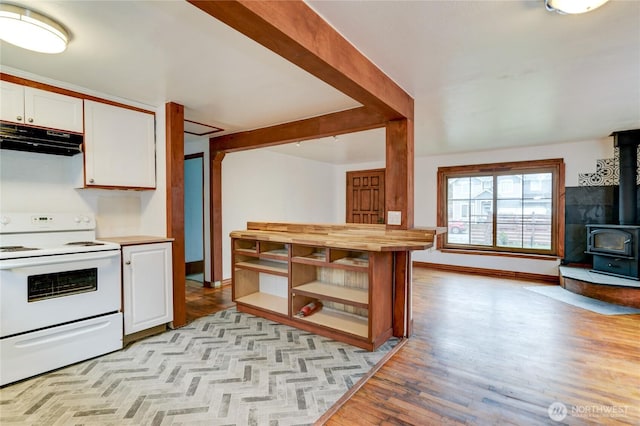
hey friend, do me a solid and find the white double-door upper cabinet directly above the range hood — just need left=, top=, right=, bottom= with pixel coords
left=0, top=81, right=83, bottom=133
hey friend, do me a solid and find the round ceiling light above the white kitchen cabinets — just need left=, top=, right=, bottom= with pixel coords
left=0, top=4, right=69, bottom=53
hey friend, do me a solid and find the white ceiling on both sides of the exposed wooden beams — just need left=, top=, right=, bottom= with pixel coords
left=0, top=0, right=640, bottom=164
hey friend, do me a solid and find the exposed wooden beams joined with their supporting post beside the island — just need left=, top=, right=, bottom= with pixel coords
left=187, top=0, right=414, bottom=336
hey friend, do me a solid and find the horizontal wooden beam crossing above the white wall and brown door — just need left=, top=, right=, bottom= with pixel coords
left=209, top=107, right=386, bottom=152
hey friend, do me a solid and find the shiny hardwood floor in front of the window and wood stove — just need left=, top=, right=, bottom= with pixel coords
left=327, top=268, right=640, bottom=425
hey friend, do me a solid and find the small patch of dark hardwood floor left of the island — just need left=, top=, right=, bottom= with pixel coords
left=185, top=279, right=236, bottom=323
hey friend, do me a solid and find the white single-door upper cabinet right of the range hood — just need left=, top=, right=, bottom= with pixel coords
left=84, top=100, right=156, bottom=189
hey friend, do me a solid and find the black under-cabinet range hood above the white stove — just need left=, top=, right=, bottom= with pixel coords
left=0, top=123, right=84, bottom=156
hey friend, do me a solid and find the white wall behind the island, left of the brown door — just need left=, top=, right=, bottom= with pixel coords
left=222, top=149, right=344, bottom=279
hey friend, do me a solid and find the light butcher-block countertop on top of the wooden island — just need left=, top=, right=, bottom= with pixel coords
left=230, top=222, right=446, bottom=251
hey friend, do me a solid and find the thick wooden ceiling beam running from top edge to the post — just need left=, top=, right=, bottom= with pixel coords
left=188, top=0, right=413, bottom=120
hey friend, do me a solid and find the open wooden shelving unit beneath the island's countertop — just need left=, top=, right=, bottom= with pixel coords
left=232, top=233, right=393, bottom=350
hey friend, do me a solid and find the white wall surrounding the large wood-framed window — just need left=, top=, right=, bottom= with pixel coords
left=413, top=138, right=613, bottom=275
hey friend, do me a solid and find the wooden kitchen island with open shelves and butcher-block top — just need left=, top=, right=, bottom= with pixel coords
left=230, top=222, right=442, bottom=351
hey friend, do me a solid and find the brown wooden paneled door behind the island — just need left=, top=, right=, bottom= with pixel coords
left=347, top=169, right=384, bottom=223
